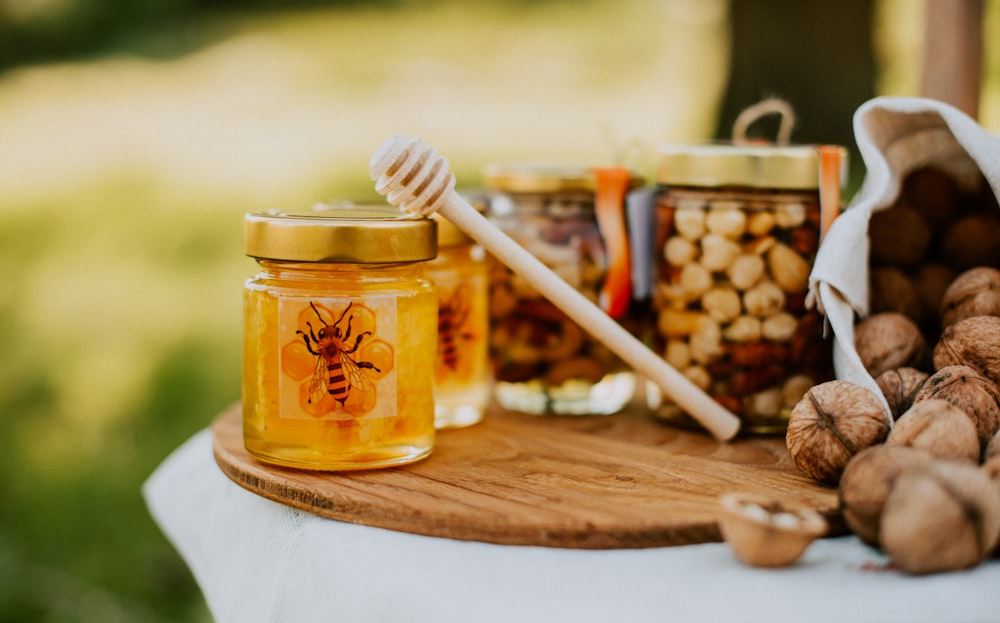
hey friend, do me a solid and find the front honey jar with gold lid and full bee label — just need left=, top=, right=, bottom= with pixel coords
left=243, top=206, right=437, bottom=470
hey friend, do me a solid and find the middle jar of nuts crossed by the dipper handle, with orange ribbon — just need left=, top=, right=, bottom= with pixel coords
left=485, top=166, right=642, bottom=415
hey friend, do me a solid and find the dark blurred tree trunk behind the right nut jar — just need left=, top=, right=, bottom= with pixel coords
left=716, top=0, right=875, bottom=150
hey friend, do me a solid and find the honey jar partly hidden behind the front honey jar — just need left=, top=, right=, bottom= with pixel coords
left=427, top=215, right=490, bottom=429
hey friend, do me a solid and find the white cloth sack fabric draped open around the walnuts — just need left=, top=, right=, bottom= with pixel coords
left=809, top=97, right=1000, bottom=422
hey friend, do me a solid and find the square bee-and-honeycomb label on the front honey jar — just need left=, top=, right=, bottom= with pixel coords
left=278, top=297, right=396, bottom=420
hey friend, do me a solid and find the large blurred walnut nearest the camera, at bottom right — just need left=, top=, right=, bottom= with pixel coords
left=879, top=461, right=1000, bottom=574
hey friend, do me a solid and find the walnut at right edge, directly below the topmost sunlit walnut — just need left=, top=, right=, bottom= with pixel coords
left=934, top=316, right=1000, bottom=392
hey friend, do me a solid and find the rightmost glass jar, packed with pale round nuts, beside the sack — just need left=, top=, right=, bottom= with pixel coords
left=647, top=143, right=844, bottom=434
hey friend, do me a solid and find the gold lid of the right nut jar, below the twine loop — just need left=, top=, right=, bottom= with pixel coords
left=656, top=143, right=847, bottom=190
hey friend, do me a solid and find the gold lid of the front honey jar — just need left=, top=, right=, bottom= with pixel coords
left=243, top=205, right=438, bottom=264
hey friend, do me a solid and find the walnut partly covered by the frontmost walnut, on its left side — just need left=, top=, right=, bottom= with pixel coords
left=837, top=444, right=934, bottom=547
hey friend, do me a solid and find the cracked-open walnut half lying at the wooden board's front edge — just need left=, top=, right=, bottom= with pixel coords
left=719, top=493, right=827, bottom=567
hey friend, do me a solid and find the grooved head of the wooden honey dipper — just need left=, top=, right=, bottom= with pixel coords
left=368, top=135, right=455, bottom=217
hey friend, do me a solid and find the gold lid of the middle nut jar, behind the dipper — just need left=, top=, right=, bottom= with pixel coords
left=483, top=164, right=644, bottom=193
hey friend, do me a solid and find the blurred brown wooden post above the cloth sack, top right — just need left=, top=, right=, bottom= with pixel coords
left=921, top=0, right=983, bottom=119
